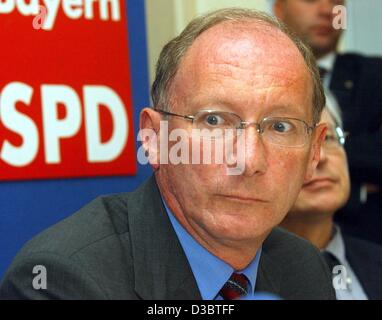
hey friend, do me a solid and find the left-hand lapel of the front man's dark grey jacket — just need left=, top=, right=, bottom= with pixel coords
left=127, top=176, right=201, bottom=300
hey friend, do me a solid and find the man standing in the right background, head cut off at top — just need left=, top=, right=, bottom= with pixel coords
left=273, top=0, right=382, bottom=243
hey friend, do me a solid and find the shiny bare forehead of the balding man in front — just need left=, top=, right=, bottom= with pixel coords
left=172, top=22, right=312, bottom=115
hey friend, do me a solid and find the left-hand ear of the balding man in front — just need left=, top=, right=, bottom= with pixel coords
left=139, top=108, right=161, bottom=171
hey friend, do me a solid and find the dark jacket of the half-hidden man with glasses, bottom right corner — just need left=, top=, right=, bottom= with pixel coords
left=343, top=234, right=382, bottom=300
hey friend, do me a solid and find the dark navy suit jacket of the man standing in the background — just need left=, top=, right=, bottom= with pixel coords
left=330, top=53, right=382, bottom=244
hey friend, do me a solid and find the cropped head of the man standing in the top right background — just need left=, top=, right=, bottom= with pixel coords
left=273, top=0, right=345, bottom=58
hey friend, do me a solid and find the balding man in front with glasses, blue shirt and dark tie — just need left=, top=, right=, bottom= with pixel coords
left=0, top=9, right=334, bottom=300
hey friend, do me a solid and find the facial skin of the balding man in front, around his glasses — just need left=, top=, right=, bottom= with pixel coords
left=151, top=23, right=322, bottom=248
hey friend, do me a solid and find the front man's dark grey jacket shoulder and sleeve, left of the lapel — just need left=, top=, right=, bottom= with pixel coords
left=0, top=194, right=136, bottom=299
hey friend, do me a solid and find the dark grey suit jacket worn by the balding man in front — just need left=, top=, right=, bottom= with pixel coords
left=0, top=178, right=335, bottom=299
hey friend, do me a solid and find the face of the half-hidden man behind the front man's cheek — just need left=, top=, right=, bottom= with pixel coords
left=290, top=110, right=350, bottom=217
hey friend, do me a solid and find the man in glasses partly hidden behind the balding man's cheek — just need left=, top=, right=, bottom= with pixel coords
left=281, top=90, right=382, bottom=300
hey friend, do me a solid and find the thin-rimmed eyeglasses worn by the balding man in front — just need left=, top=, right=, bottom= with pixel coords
left=154, top=109, right=314, bottom=147
